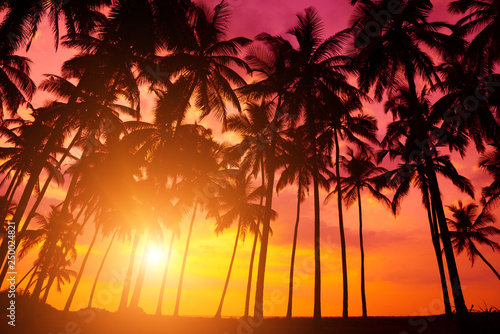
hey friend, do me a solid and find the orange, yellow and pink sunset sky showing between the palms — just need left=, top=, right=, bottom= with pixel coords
left=4, top=0, right=500, bottom=316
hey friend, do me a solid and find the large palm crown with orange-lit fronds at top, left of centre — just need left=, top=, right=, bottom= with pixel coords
left=152, top=0, right=251, bottom=128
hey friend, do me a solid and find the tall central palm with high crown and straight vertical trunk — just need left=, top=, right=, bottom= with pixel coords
left=288, top=8, right=364, bottom=323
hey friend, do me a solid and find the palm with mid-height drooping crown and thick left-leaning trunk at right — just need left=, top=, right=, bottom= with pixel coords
left=380, top=87, right=474, bottom=313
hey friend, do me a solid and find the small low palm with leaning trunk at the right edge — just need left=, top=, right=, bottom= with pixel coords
left=446, top=201, right=500, bottom=280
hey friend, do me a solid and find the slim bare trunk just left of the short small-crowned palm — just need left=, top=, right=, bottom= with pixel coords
left=333, top=129, right=349, bottom=318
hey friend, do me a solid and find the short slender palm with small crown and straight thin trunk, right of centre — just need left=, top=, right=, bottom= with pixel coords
left=330, top=148, right=391, bottom=317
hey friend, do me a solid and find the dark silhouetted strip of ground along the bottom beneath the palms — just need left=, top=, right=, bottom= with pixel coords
left=0, top=307, right=500, bottom=334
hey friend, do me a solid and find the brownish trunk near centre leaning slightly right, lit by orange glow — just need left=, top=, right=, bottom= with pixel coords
left=254, top=96, right=281, bottom=323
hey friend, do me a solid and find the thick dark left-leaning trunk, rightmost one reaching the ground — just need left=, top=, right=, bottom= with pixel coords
left=425, top=155, right=468, bottom=314
